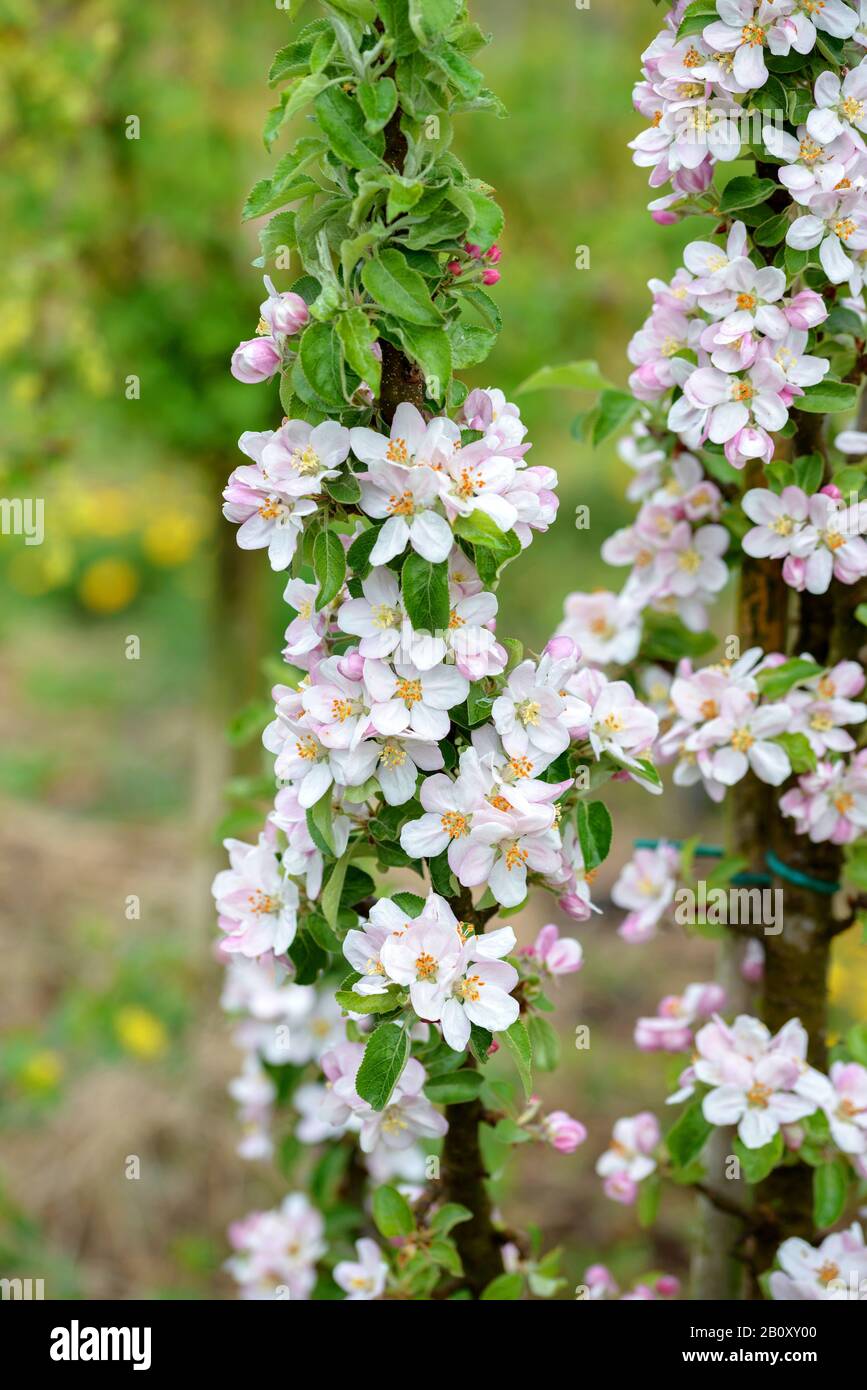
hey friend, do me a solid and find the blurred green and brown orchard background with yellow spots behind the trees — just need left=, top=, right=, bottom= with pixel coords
left=0, top=0, right=867, bottom=1300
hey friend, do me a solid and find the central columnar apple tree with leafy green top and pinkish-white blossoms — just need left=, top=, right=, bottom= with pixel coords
left=214, top=0, right=659, bottom=1298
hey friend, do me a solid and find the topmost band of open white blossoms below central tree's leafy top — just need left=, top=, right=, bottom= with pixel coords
left=224, top=391, right=557, bottom=570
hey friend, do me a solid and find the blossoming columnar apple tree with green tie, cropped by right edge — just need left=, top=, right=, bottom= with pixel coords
left=540, top=0, right=867, bottom=1301
